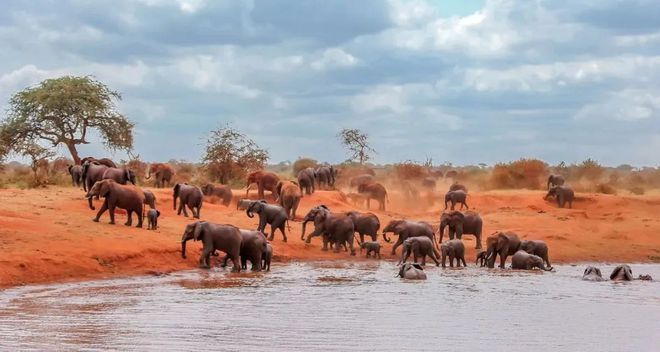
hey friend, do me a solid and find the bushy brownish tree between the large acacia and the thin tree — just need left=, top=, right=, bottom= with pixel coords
left=202, top=126, right=269, bottom=184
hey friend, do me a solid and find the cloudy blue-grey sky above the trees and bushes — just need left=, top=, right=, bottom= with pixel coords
left=0, top=0, right=660, bottom=166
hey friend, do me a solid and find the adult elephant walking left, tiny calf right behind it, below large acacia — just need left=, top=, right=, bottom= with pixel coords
left=86, top=180, right=144, bottom=227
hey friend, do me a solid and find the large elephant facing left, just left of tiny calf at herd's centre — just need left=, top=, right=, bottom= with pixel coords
left=300, top=205, right=355, bottom=255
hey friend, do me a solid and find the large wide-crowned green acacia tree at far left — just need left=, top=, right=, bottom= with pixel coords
left=0, top=76, right=134, bottom=163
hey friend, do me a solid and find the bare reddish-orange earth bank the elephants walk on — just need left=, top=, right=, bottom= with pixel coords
left=0, top=187, right=660, bottom=287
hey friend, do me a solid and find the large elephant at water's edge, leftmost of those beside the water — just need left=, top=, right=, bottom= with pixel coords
left=181, top=221, right=243, bottom=272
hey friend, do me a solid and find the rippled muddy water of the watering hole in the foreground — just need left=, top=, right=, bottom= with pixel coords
left=0, top=262, right=660, bottom=351
